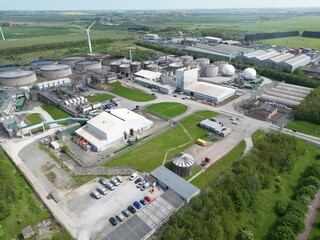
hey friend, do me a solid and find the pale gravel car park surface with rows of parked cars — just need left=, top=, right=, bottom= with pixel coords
left=62, top=173, right=162, bottom=239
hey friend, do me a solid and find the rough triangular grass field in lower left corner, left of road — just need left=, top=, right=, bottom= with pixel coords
left=0, top=150, right=51, bottom=239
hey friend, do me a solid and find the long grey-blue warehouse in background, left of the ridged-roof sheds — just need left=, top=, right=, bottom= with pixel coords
left=182, top=44, right=252, bottom=61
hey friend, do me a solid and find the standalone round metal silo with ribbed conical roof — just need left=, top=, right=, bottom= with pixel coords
left=171, top=152, right=195, bottom=177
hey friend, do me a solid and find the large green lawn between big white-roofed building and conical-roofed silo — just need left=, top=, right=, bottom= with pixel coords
left=104, top=111, right=217, bottom=172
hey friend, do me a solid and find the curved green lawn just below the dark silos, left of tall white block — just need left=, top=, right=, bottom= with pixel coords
left=111, top=82, right=156, bottom=102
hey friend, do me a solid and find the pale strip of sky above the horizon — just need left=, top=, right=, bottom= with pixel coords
left=0, top=0, right=320, bottom=10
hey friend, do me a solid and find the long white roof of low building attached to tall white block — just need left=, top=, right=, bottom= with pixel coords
left=184, top=82, right=236, bottom=99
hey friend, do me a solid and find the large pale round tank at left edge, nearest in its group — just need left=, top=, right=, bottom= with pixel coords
left=0, top=71, right=37, bottom=87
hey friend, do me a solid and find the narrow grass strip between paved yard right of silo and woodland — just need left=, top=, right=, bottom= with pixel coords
left=191, top=141, right=246, bottom=189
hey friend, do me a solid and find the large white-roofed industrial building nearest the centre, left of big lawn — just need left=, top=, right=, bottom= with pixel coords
left=75, top=108, right=153, bottom=151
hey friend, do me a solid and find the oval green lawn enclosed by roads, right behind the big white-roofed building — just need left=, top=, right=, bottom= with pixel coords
left=146, top=102, right=188, bottom=118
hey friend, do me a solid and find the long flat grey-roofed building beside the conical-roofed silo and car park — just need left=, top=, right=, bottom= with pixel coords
left=150, top=166, right=200, bottom=203
